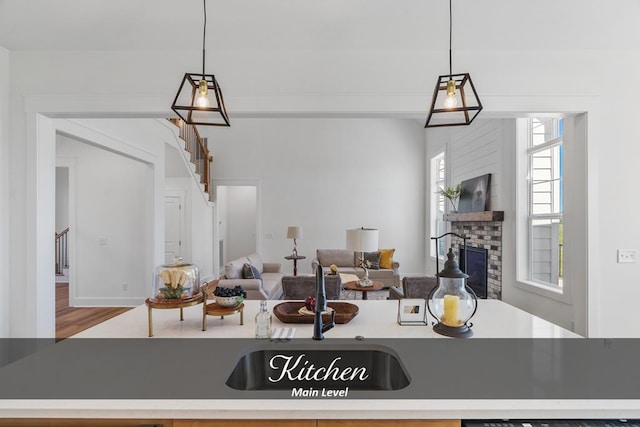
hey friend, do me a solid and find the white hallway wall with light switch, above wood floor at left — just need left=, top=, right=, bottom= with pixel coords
left=56, top=135, right=153, bottom=306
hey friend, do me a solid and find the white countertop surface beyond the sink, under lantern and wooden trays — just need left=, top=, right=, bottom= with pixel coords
left=74, top=300, right=578, bottom=338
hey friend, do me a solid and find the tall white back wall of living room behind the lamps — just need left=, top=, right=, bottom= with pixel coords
left=209, top=118, right=425, bottom=274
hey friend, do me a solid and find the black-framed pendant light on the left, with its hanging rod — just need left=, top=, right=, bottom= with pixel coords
left=171, top=0, right=231, bottom=126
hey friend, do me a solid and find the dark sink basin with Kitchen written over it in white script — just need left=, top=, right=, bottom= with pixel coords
left=226, top=343, right=411, bottom=390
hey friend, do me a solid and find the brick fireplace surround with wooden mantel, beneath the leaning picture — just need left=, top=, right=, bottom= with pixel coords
left=444, top=211, right=504, bottom=299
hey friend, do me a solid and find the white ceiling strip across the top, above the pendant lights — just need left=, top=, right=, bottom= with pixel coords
left=0, top=0, right=640, bottom=50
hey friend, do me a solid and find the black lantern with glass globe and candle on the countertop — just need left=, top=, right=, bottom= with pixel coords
left=427, top=233, right=478, bottom=338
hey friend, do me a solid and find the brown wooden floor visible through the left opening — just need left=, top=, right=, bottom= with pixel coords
left=56, top=283, right=131, bottom=339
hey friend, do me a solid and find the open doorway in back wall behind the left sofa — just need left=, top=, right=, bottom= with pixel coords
left=215, top=181, right=260, bottom=271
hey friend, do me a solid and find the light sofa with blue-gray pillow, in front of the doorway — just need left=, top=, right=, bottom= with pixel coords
left=218, top=254, right=283, bottom=300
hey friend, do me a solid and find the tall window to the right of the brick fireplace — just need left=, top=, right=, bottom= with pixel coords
left=525, top=118, right=563, bottom=290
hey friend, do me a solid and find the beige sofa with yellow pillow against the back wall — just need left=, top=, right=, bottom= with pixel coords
left=311, top=249, right=400, bottom=288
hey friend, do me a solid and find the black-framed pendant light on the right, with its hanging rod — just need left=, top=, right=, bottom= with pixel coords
left=424, top=0, right=482, bottom=128
